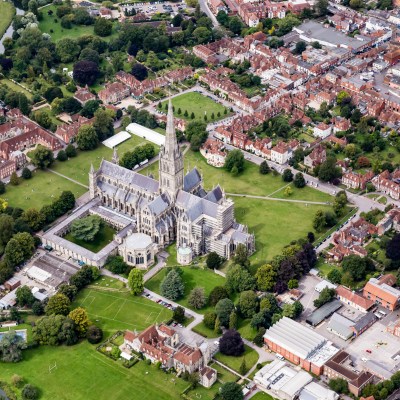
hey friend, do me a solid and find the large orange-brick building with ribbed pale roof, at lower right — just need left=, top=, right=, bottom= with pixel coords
left=264, top=317, right=339, bottom=375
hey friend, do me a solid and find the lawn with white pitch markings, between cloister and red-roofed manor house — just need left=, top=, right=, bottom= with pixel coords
left=73, top=287, right=172, bottom=335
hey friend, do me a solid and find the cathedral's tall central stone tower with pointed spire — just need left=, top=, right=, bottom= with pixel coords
left=159, top=99, right=183, bottom=199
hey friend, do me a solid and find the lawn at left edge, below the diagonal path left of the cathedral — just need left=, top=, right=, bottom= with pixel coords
left=1, top=170, right=87, bottom=210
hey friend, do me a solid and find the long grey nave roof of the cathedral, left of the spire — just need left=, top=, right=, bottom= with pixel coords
left=99, top=160, right=159, bottom=193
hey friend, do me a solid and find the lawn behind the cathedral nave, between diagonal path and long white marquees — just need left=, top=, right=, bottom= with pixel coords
left=51, top=135, right=159, bottom=185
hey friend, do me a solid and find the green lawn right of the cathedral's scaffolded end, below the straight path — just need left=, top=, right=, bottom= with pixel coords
left=233, top=197, right=332, bottom=270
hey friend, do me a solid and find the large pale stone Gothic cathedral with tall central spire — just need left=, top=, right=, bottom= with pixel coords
left=89, top=101, right=255, bottom=259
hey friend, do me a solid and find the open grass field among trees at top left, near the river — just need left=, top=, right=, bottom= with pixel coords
left=39, top=6, right=116, bottom=42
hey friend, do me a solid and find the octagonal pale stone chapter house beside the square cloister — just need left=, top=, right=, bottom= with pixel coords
left=118, top=233, right=157, bottom=269
